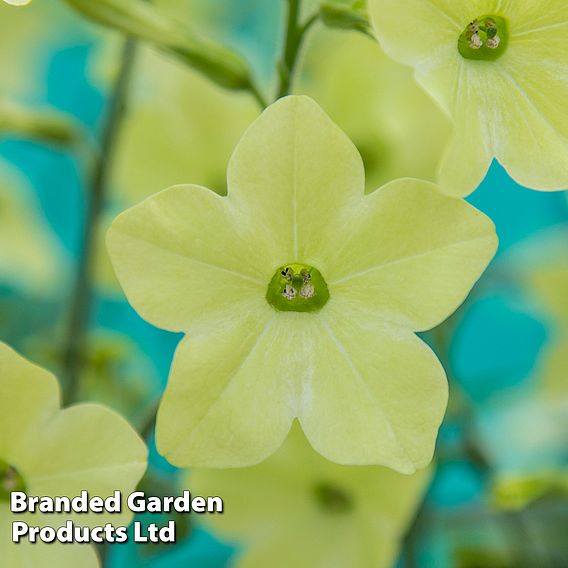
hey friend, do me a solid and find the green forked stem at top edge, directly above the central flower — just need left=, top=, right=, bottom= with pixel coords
left=276, top=0, right=318, bottom=100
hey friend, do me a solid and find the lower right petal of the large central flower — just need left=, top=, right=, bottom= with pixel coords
left=299, top=300, right=448, bottom=473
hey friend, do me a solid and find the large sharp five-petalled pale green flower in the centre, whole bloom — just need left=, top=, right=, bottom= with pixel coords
left=108, top=96, right=497, bottom=473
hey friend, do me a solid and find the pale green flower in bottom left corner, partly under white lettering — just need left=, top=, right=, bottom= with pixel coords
left=0, top=343, right=146, bottom=568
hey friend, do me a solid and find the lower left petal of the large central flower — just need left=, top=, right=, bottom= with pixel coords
left=156, top=304, right=301, bottom=467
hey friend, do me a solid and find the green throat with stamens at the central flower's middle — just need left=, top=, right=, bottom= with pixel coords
left=266, top=263, right=329, bottom=312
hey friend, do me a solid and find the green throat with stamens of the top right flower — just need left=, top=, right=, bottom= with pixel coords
left=458, top=16, right=509, bottom=61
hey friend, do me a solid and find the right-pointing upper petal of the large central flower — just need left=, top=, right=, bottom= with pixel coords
left=326, top=179, right=497, bottom=331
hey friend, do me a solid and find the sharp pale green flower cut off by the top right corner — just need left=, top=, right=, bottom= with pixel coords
left=369, top=0, right=568, bottom=195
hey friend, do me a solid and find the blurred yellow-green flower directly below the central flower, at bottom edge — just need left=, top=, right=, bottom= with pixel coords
left=187, top=427, right=430, bottom=568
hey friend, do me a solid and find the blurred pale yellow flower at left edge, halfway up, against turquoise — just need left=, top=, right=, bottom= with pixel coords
left=0, top=162, right=66, bottom=295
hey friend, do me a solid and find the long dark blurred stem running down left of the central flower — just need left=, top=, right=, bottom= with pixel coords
left=63, top=38, right=137, bottom=404
